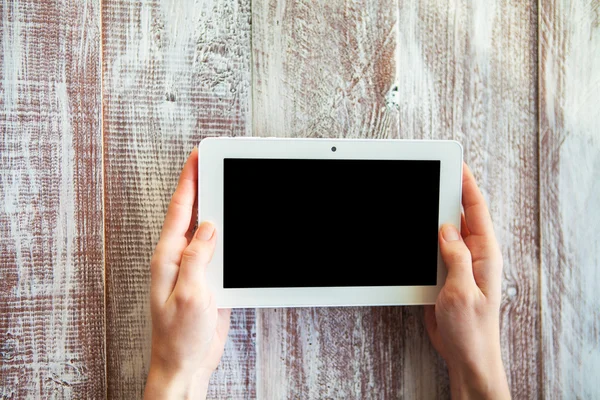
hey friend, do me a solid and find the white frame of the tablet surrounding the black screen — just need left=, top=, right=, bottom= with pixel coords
left=198, top=137, right=462, bottom=308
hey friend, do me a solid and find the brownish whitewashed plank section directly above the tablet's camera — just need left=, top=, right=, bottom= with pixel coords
left=252, top=0, right=397, bottom=138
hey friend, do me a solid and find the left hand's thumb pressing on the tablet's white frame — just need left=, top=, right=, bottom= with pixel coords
left=173, top=222, right=217, bottom=308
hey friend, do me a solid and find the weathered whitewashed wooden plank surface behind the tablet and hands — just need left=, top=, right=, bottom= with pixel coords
left=0, top=0, right=600, bottom=399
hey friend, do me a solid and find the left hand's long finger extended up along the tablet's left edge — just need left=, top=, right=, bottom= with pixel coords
left=160, top=147, right=198, bottom=241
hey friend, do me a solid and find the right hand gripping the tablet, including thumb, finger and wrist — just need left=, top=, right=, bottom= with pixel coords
left=425, top=164, right=510, bottom=399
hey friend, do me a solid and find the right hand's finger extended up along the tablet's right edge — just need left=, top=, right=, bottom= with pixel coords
left=462, top=163, right=494, bottom=236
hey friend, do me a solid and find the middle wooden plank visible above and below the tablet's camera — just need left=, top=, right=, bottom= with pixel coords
left=252, top=0, right=403, bottom=399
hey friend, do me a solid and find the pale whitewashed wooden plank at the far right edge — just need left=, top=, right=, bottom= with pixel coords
left=539, top=0, right=600, bottom=399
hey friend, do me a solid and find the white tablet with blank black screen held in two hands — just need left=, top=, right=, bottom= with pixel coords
left=198, top=138, right=462, bottom=307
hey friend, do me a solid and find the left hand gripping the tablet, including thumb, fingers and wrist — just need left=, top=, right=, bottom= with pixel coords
left=144, top=149, right=231, bottom=399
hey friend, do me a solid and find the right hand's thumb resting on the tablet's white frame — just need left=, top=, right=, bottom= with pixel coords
left=439, top=224, right=475, bottom=283
